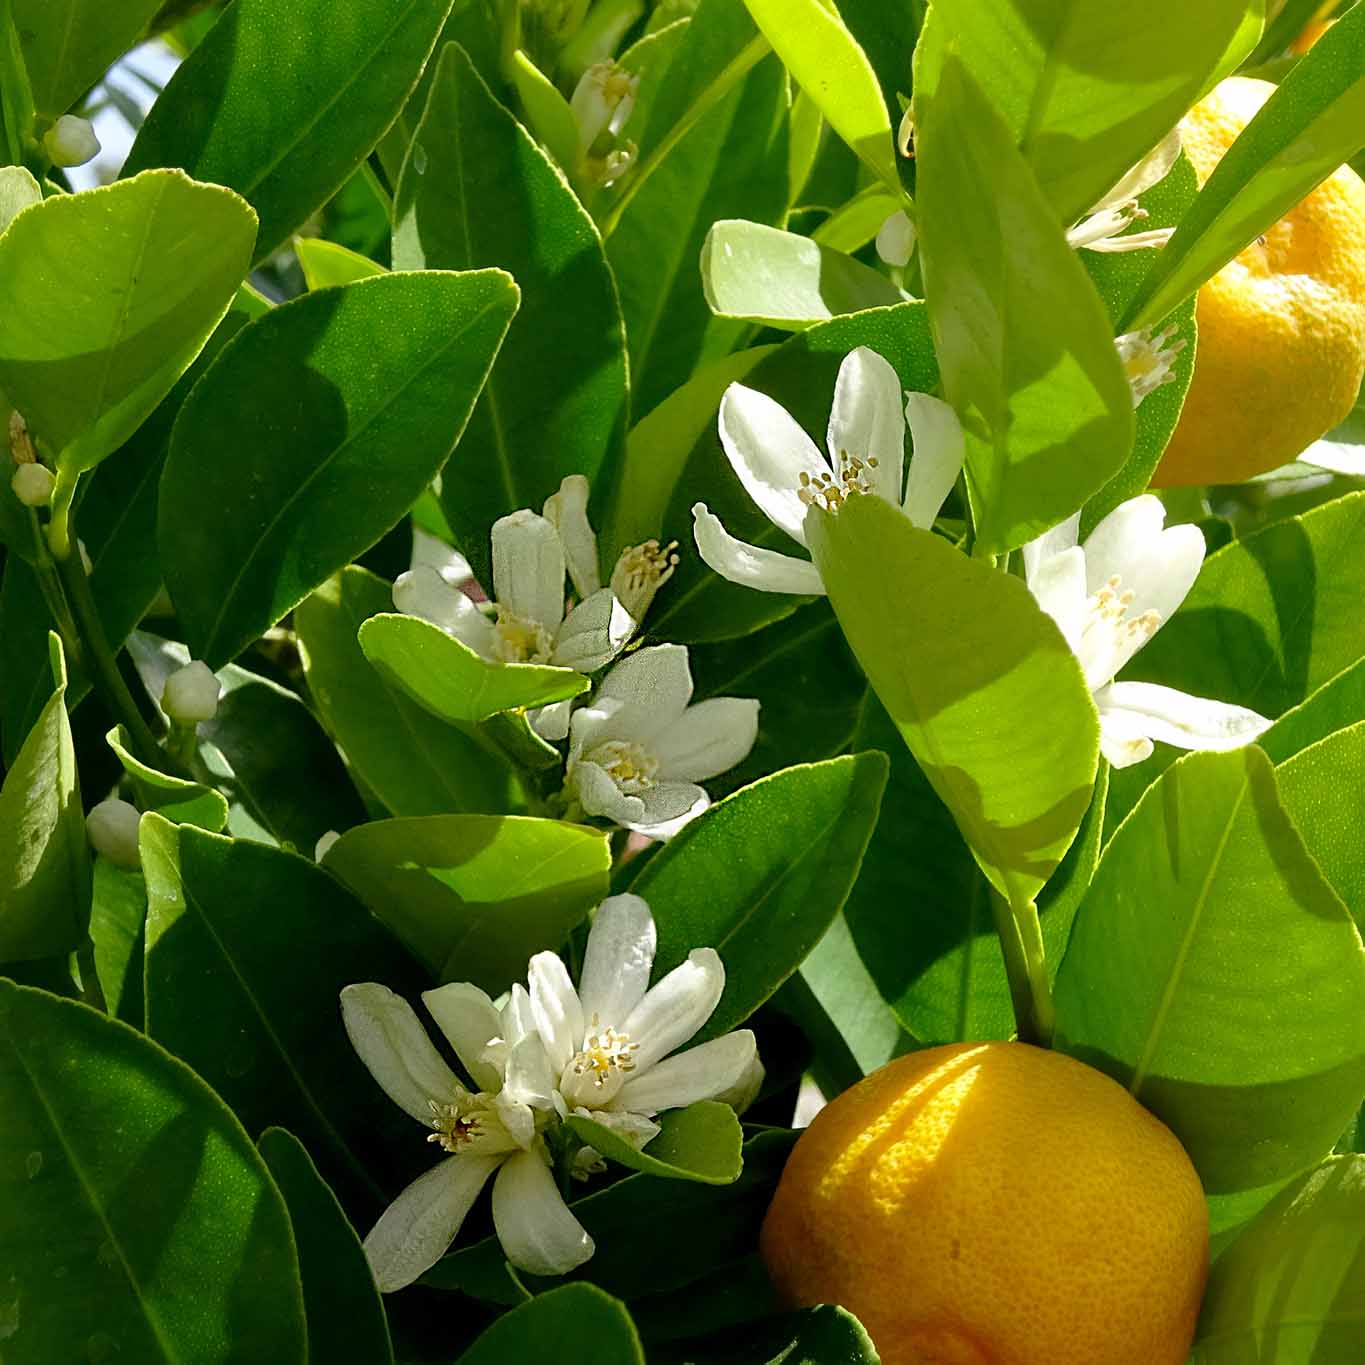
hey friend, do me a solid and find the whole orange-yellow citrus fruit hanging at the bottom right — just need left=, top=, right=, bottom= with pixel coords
left=762, top=1043, right=1208, bottom=1365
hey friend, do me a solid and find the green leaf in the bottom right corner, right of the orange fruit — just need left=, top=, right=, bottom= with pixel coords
left=1190, top=1156, right=1365, bottom=1365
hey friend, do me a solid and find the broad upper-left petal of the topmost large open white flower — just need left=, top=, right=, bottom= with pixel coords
left=719, top=384, right=830, bottom=545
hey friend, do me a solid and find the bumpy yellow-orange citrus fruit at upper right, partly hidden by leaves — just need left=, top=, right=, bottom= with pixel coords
left=1152, top=76, right=1365, bottom=486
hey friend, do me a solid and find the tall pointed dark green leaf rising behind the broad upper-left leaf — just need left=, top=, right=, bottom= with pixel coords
left=393, top=44, right=627, bottom=581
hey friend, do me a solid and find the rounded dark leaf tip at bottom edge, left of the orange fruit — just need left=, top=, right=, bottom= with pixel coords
left=457, top=1284, right=644, bottom=1365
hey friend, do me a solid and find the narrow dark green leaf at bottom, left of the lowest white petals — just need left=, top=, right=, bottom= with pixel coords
left=257, top=1127, right=393, bottom=1365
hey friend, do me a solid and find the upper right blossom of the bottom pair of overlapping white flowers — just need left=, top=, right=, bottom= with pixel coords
left=530, top=895, right=763, bottom=1173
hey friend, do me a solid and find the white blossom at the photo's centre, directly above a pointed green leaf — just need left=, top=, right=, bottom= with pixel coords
left=565, top=644, right=759, bottom=839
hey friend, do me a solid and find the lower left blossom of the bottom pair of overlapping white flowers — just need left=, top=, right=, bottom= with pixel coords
left=341, top=981, right=594, bottom=1293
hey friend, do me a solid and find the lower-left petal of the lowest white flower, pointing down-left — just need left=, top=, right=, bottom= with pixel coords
left=364, top=1156, right=502, bottom=1294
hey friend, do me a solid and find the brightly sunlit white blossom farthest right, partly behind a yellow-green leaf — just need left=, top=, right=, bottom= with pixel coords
left=1024, top=494, right=1271, bottom=767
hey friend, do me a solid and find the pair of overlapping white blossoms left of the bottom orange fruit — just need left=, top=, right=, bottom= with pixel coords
left=341, top=895, right=763, bottom=1293
